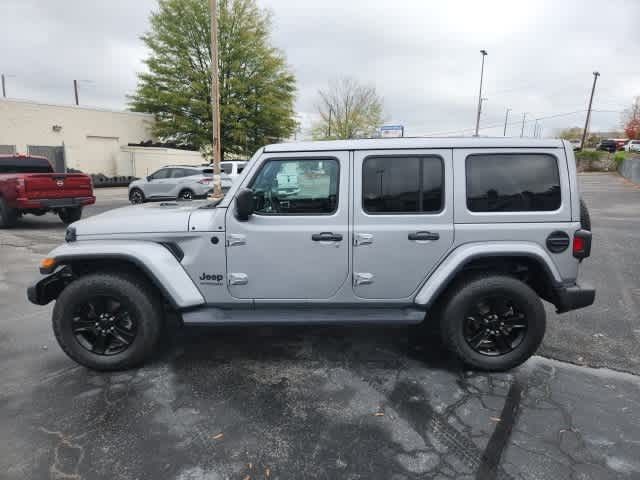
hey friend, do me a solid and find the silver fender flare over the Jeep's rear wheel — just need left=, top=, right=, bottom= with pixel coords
left=414, top=242, right=562, bottom=308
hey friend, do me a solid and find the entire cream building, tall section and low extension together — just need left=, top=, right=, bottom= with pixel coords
left=0, top=99, right=203, bottom=177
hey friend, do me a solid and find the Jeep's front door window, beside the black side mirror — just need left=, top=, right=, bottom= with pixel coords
left=251, top=158, right=339, bottom=215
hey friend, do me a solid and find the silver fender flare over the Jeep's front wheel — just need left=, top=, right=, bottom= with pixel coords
left=31, top=240, right=205, bottom=309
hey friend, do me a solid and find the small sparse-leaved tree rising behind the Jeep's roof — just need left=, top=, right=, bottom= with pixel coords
left=311, top=78, right=383, bottom=140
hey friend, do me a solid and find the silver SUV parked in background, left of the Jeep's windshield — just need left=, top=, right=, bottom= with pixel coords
left=129, top=165, right=233, bottom=204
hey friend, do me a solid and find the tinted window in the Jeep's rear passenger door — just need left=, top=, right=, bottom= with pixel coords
left=362, top=156, right=444, bottom=213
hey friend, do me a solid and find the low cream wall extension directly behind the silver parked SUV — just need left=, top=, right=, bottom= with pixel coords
left=116, top=147, right=204, bottom=178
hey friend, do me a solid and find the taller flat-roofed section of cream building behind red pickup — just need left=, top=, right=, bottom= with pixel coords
left=0, top=99, right=155, bottom=176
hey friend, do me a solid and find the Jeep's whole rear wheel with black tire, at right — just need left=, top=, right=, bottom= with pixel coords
left=440, top=274, right=546, bottom=371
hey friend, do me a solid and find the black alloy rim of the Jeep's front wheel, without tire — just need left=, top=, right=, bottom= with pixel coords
left=71, top=295, right=138, bottom=356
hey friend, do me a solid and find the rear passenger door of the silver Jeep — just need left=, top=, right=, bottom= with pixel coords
left=353, top=150, right=454, bottom=299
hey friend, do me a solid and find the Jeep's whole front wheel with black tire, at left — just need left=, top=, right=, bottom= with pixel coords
left=52, top=273, right=164, bottom=371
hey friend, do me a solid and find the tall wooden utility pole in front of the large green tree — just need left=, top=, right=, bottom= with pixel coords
left=209, top=0, right=223, bottom=200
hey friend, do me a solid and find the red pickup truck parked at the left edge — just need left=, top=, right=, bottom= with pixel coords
left=0, top=155, right=96, bottom=228
